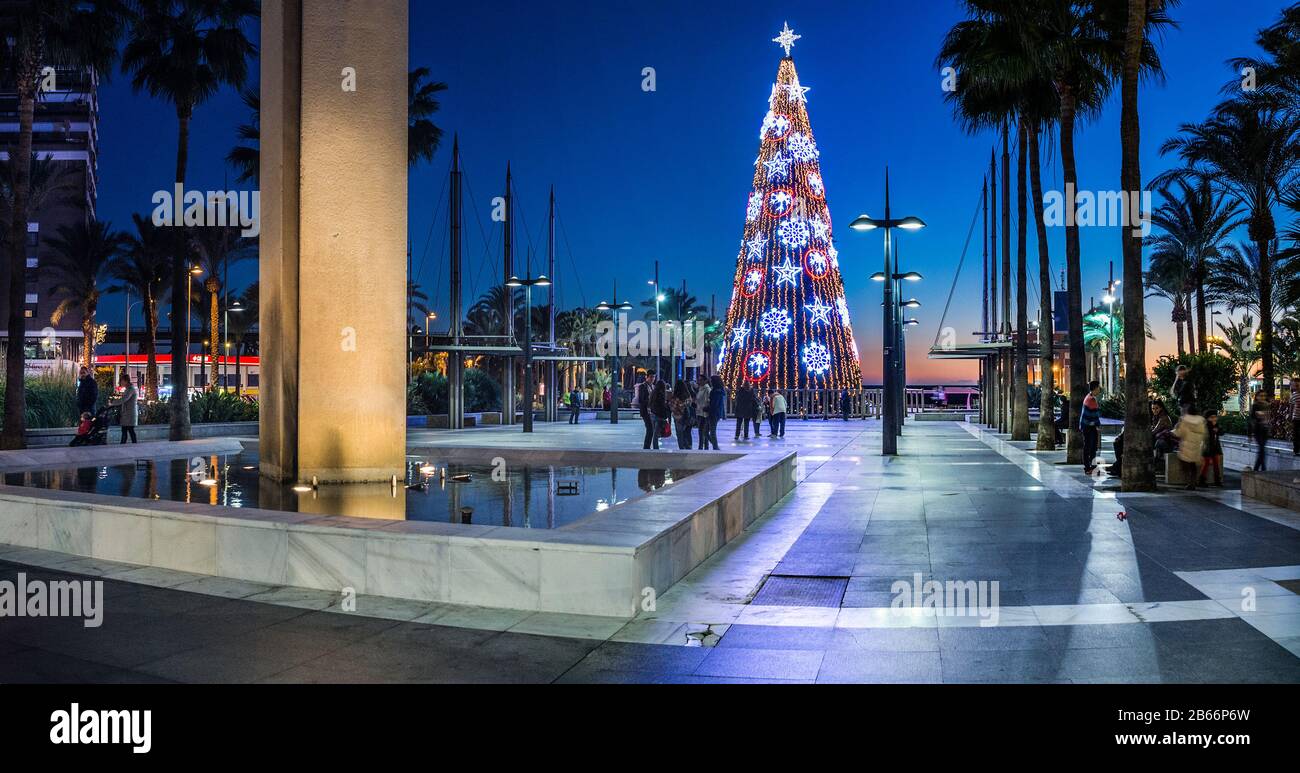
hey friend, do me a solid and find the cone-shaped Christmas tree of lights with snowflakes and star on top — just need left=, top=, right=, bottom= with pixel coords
left=722, top=25, right=862, bottom=390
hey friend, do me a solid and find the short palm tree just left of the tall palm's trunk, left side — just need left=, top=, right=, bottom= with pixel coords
left=108, top=214, right=185, bottom=401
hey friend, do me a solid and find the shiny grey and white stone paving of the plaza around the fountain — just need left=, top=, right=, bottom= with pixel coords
left=0, top=420, right=1300, bottom=683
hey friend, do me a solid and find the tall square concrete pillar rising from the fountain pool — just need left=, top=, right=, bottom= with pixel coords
left=260, top=0, right=408, bottom=482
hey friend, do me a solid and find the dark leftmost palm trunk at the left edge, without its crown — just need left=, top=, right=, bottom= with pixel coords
left=0, top=57, right=40, bottom=451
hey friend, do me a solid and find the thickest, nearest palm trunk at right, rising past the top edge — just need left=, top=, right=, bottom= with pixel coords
left=1119, top=0, right=1154, bottom=491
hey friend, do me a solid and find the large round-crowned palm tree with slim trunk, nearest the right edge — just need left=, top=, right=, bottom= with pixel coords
left=1160, top=99, right=1300, bottom=400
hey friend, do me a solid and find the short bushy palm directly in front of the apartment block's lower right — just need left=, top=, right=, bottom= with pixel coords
left=49, top=220, right=124, bottom=368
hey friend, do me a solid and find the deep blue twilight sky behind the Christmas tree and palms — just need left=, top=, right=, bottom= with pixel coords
left=91, top=0, right=1287, bottom=382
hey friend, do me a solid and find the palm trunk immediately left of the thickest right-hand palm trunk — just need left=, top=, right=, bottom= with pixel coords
left=1060, top=84, right=1086, bottom=464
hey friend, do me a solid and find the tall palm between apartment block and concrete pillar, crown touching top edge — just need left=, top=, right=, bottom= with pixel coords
left=122, top=0, right=260, bottom=440
